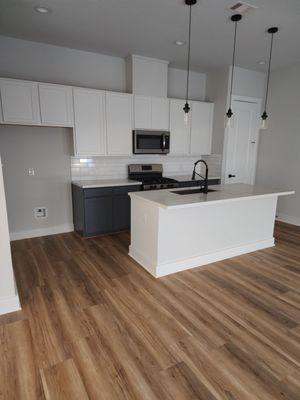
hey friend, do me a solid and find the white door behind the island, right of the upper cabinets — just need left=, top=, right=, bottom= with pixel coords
left=225, top=99, right=261, bottom=184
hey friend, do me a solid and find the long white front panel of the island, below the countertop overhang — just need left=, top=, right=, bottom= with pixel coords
left=156, top=196, right=277, bottom=277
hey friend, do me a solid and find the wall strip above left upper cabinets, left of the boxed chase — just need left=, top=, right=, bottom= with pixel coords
left=0, top=36, right=126, bottom=91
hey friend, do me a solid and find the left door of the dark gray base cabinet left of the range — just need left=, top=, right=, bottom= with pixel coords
left=84, top=196, right=113, bottom=236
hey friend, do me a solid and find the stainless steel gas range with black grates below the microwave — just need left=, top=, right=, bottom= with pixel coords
left=128, top=164, right=179, bottom=190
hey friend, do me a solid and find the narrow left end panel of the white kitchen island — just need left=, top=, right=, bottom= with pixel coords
left=129, top=194, right=159, bottom=277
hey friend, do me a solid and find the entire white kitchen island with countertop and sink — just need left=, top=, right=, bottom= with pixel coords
left=129, top=184, right=294, bottom=278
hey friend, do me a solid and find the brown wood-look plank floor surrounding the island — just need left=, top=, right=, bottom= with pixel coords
left=0, top=223, right=300, bottom=400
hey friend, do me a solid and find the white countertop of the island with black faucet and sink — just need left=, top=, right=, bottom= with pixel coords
left=129, top=183, right=295, bottom=209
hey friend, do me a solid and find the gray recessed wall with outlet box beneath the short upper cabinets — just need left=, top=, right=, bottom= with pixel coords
left=0, top=125, right=72, bottom=235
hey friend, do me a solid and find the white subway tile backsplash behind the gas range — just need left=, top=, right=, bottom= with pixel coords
left=71, top=154, right=222, bottom=180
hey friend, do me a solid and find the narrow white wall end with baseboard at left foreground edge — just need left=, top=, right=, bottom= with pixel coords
left=0, top=158, right=20, bottom=314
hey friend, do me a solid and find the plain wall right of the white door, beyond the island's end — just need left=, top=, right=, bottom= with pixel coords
left=256, top=65, right=300, bottom=225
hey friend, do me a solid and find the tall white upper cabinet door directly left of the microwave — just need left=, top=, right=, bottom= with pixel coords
left=106, top=92, right=133, bottom=155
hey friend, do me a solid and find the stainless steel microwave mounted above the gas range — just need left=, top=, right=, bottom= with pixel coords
left=132, top=129, right=170, bottom=154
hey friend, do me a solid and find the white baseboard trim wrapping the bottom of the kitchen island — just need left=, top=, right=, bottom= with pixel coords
left=129, top=238, right=274, bottom=278
